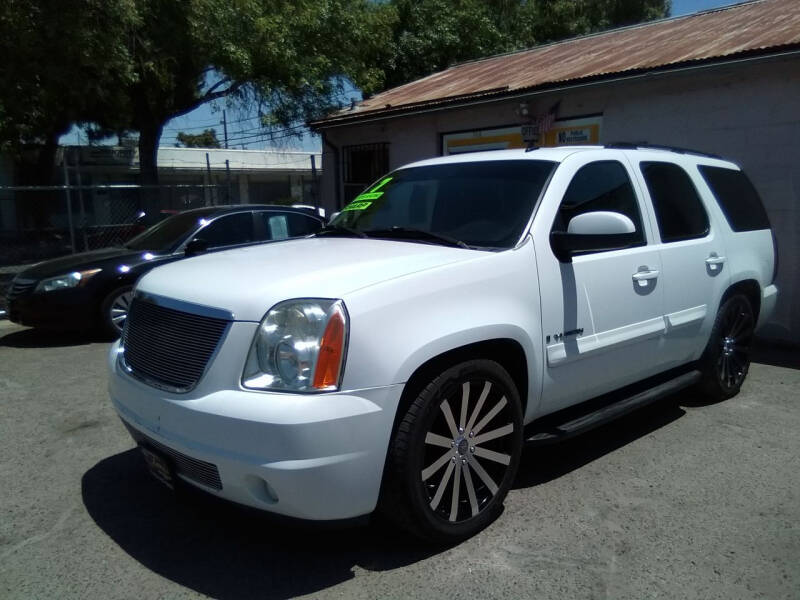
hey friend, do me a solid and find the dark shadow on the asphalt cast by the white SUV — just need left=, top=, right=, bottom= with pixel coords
left=82, top=398, right=685, bottom=599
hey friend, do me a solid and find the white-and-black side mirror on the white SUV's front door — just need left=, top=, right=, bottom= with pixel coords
left=550, top=210, right=640, bottom=262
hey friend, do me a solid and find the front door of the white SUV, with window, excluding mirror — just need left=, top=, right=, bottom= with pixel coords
left=533, top=150, right=664, bottom=412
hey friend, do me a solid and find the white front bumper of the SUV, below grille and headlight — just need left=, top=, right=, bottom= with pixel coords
left=109, top=340, right=403, bottom=520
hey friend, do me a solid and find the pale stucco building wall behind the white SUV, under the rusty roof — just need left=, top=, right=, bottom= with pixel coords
left=321, top=58, right=800, bottom=343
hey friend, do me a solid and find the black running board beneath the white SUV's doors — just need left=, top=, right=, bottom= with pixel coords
left=525, top=371, right=702, bottom=444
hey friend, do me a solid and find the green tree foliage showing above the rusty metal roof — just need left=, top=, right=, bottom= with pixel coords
left=365, top=0, right=670, bottom=93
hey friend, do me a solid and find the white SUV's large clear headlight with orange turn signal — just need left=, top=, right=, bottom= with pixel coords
left=242, top=298, right=347, bottom=392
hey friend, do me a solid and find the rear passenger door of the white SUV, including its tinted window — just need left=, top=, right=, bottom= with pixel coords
left=629, top=152, right=729, bottom=367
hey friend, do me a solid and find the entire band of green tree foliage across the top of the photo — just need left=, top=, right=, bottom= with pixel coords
left=0, top=0, right=669, bottom=181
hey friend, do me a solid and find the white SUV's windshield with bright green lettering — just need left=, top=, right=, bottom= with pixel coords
left=330, top=160, right=555, bottom=249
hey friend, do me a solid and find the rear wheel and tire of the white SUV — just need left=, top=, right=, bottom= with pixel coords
left=698, top=294, right=756, bottom=401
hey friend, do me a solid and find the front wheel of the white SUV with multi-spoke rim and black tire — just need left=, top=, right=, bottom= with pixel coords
left=380, top=360, right=522, bottom=544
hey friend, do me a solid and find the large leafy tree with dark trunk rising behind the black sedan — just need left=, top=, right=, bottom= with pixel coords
left=100, top=0, right=378, bottom=184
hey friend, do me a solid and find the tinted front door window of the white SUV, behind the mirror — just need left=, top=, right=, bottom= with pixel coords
left=553, top=160, right=646, bottom=246
